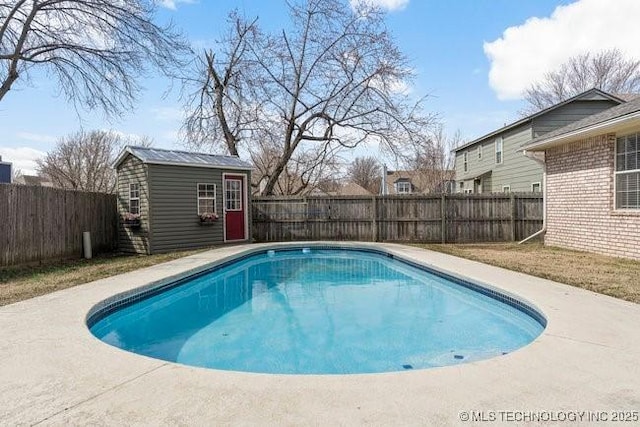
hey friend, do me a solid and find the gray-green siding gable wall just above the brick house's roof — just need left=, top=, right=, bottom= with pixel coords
left=532, top=100, right=619, bottom=137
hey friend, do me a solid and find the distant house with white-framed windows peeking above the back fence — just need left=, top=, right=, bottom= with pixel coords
left=381, top=170, right=455, bottom=195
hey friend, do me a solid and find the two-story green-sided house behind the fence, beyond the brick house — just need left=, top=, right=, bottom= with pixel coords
left=454, top=89, right=625, bottom=193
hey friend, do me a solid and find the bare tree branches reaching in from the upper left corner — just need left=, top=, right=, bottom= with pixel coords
left=0, top=0, right=186, bottom=115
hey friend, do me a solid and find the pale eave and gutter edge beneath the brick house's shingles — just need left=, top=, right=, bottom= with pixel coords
left=521, top=111, right=640, bottom=152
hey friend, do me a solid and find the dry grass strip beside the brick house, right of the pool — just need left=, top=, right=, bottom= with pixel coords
left=415, top=243, right=640, bottom=303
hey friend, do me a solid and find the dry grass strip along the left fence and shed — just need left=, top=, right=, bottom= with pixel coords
left=0, top=249, right=204, bottom=306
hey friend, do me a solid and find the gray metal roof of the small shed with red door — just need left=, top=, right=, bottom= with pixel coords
left=113, top=146, right=253, bottom=170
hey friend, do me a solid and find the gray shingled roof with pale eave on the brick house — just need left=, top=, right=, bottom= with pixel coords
left=522, top=97, right=640, bottom=151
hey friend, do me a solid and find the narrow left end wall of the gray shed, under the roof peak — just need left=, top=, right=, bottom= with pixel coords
left=117, top=155, right=151, bottom=254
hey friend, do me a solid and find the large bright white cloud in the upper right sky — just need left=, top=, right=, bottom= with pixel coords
left=484, top=0, right=640, bottom=100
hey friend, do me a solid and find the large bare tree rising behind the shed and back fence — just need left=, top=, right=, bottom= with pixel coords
left=185, top=0, right=435, bottom=195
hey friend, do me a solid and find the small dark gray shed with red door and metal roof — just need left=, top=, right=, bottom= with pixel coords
left=114, top=146, right=252, bottom=254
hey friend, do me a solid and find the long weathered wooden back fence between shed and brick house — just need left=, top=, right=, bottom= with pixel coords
left=252, top=193, right=542, bottom=243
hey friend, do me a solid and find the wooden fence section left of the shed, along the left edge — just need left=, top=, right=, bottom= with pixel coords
left=0, top=184, right=118, bottom=266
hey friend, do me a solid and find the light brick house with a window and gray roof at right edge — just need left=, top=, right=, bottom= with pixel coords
left=523, top=98, right=640, bottom=259
